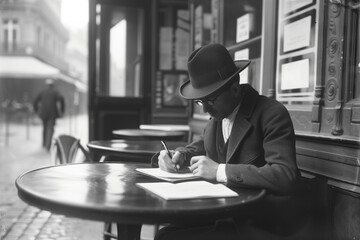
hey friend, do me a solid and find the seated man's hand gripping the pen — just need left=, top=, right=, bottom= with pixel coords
left=158, top=150, right=185, bottom=172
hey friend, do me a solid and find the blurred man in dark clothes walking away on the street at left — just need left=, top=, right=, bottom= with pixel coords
left=34, top=79, right=65, bottom=151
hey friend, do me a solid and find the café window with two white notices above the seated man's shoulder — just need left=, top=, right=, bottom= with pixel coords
left=276, top=0, right=320, bottom=105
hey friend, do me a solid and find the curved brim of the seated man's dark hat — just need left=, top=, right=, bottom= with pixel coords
left=180, top=60, right=251, bottom=99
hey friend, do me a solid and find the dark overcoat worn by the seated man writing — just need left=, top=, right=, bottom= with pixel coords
left=177, top=84, right=299, bottom=194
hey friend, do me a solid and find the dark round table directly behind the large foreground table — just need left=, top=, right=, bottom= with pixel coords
left=87, top=139, right=187, bottom=163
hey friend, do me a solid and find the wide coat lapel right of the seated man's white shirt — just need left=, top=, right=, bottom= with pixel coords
left=226, top=84, right=259, bottom=162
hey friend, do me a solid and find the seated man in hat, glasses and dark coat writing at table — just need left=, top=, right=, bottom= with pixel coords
left=157, top=44, right=300, bottom=240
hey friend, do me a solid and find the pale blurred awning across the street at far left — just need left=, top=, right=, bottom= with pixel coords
left=0, top=56, right=87, bottom=92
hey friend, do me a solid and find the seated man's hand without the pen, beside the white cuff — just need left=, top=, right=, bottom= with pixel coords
left=190, top=156, right=219, bottom=181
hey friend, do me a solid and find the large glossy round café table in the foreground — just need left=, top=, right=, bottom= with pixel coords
left=16, top=163, right=265, bottom=239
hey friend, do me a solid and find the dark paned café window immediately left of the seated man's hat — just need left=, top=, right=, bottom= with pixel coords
left=152, top=1, right=190, bottom=122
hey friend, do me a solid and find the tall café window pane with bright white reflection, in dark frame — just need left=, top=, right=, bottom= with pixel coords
left=96, top=4, right=144, bottom=97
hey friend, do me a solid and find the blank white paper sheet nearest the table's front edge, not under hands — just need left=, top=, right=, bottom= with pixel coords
left=137, top=181, right=238, bottom=200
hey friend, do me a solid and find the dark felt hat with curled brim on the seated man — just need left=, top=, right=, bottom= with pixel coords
left=180, top=43, right=250, bottom=99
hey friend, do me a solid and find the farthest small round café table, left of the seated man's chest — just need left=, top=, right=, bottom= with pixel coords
left=112, top=129, right=186, bottom=141
